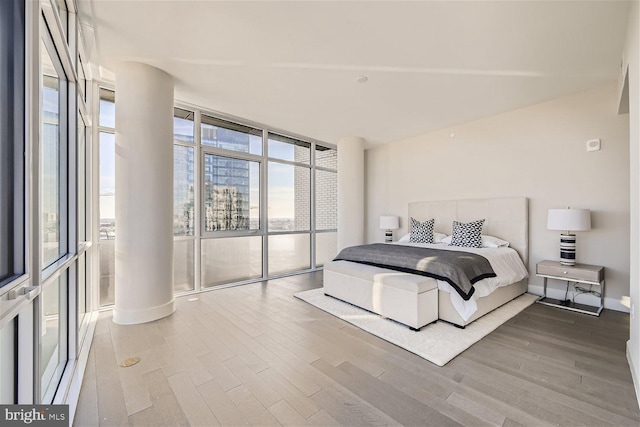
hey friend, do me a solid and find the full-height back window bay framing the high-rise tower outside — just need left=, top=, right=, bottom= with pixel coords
left=200, top=114, right=264, bottom=287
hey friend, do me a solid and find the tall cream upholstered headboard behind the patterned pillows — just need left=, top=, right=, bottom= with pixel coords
left=407, top=197, right=529, bottom=265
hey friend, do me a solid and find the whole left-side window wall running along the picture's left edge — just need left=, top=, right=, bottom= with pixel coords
left=0, top=0, right=92, bottom=404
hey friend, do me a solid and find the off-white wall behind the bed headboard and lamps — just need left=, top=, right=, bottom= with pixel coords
left=365, top=83, right=629, bottom=310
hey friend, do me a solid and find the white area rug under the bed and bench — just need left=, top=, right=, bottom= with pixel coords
left=294, top=288, right=538, bottom=366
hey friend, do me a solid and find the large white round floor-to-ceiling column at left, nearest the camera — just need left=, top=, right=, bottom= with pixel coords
left=113, top=62, right=175, bottom=325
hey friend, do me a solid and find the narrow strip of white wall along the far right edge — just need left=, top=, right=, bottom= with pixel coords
left=621, top=1, right=640, bottom=403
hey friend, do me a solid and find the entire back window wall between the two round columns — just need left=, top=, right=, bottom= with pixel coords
left=173, top=107, right=337, bottom=292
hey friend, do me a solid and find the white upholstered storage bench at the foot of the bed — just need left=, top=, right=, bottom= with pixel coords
left=324, top=261, right=438, bottom=329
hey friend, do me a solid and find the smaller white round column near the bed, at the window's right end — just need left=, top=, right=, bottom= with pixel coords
left=338, top=136, right=365, bottom=251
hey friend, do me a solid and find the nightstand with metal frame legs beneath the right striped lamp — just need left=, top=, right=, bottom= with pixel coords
left=536, top=261, right=604, bottom=316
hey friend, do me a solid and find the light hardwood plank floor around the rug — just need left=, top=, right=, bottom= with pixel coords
left=74, top=273, right=640, bottom=426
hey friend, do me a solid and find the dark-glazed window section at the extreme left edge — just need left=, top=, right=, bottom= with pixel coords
left=0, top=1, right=26, bottom=404
